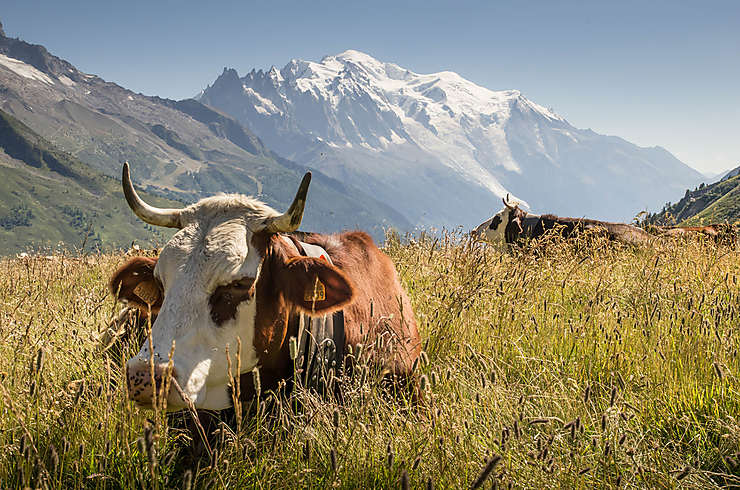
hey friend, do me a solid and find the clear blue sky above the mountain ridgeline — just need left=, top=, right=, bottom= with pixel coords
left=0, top=0, right=740, bottom=172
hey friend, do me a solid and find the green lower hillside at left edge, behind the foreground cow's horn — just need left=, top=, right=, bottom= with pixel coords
left=0, top=110, right=176, bottom=255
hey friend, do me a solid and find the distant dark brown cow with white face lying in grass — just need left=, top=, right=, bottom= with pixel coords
left=471, top=195, right=651, bottom=245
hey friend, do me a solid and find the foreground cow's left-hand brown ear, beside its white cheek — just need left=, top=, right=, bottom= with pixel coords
left=110, top=257, right=164, bottom=314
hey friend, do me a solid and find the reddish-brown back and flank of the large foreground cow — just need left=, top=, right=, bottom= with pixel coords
left=303, top=231, right=421, bottom=374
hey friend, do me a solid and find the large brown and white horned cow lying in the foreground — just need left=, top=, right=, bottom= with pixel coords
left=111, top=164, right=421, bottom=410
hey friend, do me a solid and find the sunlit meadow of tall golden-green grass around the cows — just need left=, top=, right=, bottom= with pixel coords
left=0, top=233, right=740, bottom=488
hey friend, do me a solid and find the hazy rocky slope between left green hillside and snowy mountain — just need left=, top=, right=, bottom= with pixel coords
left=0, top=25, right=411, bottom=247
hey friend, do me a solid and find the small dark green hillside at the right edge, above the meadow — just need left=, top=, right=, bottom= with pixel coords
left=647, top=169, right=740, bottom=225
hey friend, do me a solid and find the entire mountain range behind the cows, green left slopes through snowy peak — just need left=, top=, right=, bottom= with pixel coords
left=0, top=20, right=716, bottom=254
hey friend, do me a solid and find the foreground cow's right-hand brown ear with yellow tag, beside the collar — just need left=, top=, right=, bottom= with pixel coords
left=279, top=257, right=354, bottom=315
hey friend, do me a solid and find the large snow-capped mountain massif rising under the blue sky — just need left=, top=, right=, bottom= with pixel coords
left=198, top=50, right=702, bottom=226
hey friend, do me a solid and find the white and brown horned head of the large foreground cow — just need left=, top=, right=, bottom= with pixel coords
left=111, top=164, right=353, bottom=410
